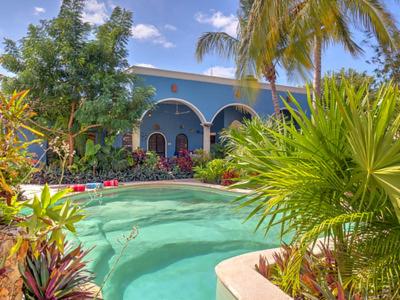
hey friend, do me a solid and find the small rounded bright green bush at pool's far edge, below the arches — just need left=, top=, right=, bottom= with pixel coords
left=193, top=159, right=231, bottom=184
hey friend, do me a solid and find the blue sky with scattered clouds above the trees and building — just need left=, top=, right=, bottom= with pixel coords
left=0, top=0, right=400, bottom=85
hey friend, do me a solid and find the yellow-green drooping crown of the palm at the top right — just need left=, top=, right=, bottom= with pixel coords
left=236, top=0, right=399, bottom=95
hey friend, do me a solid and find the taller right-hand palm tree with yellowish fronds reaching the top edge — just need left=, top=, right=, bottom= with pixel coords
left=243, top=0, right=398, bottom=98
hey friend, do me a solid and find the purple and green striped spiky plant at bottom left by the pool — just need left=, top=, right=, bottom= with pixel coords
left=19, top=243, right=94, bottom=300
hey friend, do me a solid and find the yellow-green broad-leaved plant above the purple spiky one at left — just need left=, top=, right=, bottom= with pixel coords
left=18, top=184, right=84, bottom=253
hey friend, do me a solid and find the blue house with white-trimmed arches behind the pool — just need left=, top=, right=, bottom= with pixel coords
left=119, top=66, right=306, bottom=157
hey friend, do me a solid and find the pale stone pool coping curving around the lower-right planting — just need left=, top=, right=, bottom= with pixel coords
left=215, top=248, right=293, bottom=300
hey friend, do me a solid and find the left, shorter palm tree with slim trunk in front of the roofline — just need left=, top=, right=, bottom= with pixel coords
left=196, top=0, right=311, bottom=116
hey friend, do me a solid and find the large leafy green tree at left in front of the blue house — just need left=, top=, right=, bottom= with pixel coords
left=1, top=0, right=154, bottom=164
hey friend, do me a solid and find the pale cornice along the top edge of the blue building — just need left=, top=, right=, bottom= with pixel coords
left=128, top=66, right=306, bottom=93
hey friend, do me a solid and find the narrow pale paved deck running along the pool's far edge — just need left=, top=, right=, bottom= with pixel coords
left=21, top=179, right=251, bottom=199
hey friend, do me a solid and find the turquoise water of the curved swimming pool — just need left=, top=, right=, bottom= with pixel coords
left=72, top=186, right=279, bottom=300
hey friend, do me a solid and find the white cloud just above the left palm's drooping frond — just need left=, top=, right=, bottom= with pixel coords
left=194, top=11, right=239, bottom=36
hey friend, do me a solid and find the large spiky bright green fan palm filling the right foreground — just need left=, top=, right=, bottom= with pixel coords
left=228, top=80, right=400, bottom=296
